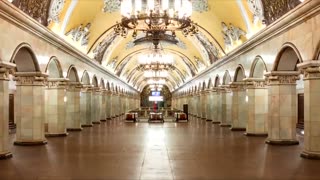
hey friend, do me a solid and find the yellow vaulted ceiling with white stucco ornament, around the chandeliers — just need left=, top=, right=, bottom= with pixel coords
left=12, top=0, right=300, bottom=91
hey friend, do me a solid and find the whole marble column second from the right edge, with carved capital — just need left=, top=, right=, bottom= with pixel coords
left=265, top=71, right=300, bottom=145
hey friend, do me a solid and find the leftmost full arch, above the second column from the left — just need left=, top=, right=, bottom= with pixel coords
left=10, top=43, right=40, bottom=72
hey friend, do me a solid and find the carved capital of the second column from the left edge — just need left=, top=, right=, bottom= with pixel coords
left=14, top=71, right=48, bottom=86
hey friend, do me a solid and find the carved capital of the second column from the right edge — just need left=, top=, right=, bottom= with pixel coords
left=265, top=71, right=300, bottom=86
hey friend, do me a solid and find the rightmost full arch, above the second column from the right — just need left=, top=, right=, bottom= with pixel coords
left=273, top=43, right=302, bottom=71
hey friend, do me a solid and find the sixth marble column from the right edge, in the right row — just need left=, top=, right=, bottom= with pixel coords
left=211, top=87, right=221, bottom=124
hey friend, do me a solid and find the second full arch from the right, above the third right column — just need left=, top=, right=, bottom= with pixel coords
left=249, top=56, right=268, bottom=78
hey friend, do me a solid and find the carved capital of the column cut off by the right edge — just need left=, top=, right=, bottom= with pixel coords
left=297, top=60, right=320, bottom=80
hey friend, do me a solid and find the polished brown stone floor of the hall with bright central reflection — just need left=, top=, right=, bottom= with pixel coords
left=0, top=120, right=320, bottom=180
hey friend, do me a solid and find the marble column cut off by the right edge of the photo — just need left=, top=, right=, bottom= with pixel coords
left=298, top=60, right=320, bottom=159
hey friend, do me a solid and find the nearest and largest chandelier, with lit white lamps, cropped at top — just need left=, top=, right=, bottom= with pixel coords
left=114, top=0, right=198, bottom=38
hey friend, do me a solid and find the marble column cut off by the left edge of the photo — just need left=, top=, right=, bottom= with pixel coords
left=0, top=61, right=15, bottom=159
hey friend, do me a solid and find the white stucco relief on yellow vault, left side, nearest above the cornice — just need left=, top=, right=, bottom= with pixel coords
left=66, top=23, right=91, bottom=46
